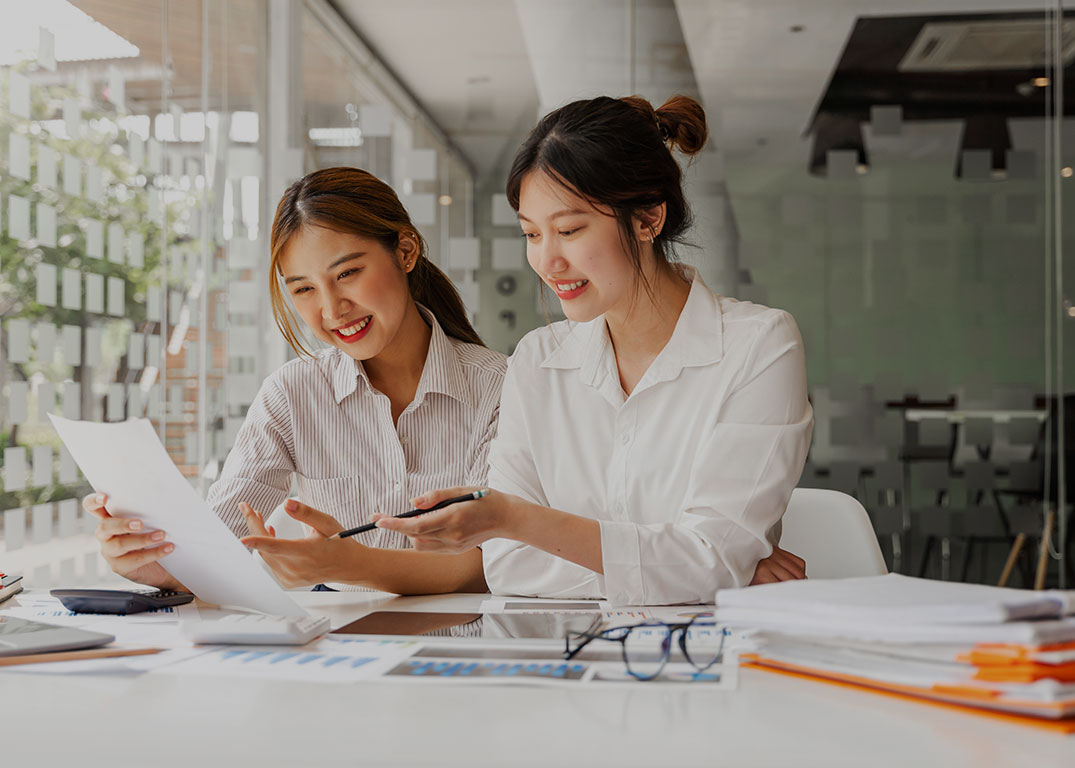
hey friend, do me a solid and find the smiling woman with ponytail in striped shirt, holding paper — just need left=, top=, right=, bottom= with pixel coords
left=83, top=168, right=506, bottom=594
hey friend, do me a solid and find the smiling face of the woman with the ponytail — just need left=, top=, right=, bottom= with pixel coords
left=280, top=226, right=417, bottom=360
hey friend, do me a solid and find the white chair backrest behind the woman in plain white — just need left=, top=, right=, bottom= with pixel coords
left=780, top=488, right=888, bottom=579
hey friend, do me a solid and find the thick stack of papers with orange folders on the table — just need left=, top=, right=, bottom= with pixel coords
left=716, top=573, right=1075, bottom=731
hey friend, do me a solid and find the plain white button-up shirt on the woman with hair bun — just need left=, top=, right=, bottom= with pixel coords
left=483, top=268, right=814, bottom=605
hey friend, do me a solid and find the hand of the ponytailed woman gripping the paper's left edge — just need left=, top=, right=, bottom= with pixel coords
left=82, top=494, right=186, bottom=591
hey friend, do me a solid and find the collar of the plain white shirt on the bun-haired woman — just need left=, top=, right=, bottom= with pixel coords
left=542, top=265, right=723, bottom=386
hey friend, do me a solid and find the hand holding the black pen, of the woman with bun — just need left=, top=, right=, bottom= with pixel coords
left=373, top=487, right=522, bottom=554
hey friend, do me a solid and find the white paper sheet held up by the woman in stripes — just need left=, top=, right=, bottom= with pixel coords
left=51, top=416, right=307, bottom=616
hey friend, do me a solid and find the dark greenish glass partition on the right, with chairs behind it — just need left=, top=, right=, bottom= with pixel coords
left=676, top=0, right=1075, bottom=587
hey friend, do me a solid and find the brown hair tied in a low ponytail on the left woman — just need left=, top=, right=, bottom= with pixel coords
left=269, top=168, right=482, bottom=355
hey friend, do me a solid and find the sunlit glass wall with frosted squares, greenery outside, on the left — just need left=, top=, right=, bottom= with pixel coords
left=0, top=0, right=477, bottom=587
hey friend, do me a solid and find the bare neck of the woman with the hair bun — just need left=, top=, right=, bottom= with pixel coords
left=605, top=260, right=690, bottom=361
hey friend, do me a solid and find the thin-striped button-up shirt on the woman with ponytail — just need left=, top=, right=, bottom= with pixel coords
left=207, top=308, right=506, bottom=588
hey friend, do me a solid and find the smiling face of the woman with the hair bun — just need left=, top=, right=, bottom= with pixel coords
left=519, top=172, right=653, bottom=323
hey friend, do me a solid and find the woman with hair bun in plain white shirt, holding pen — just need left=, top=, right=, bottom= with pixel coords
left=377, top=96, right=813, bottom=605
